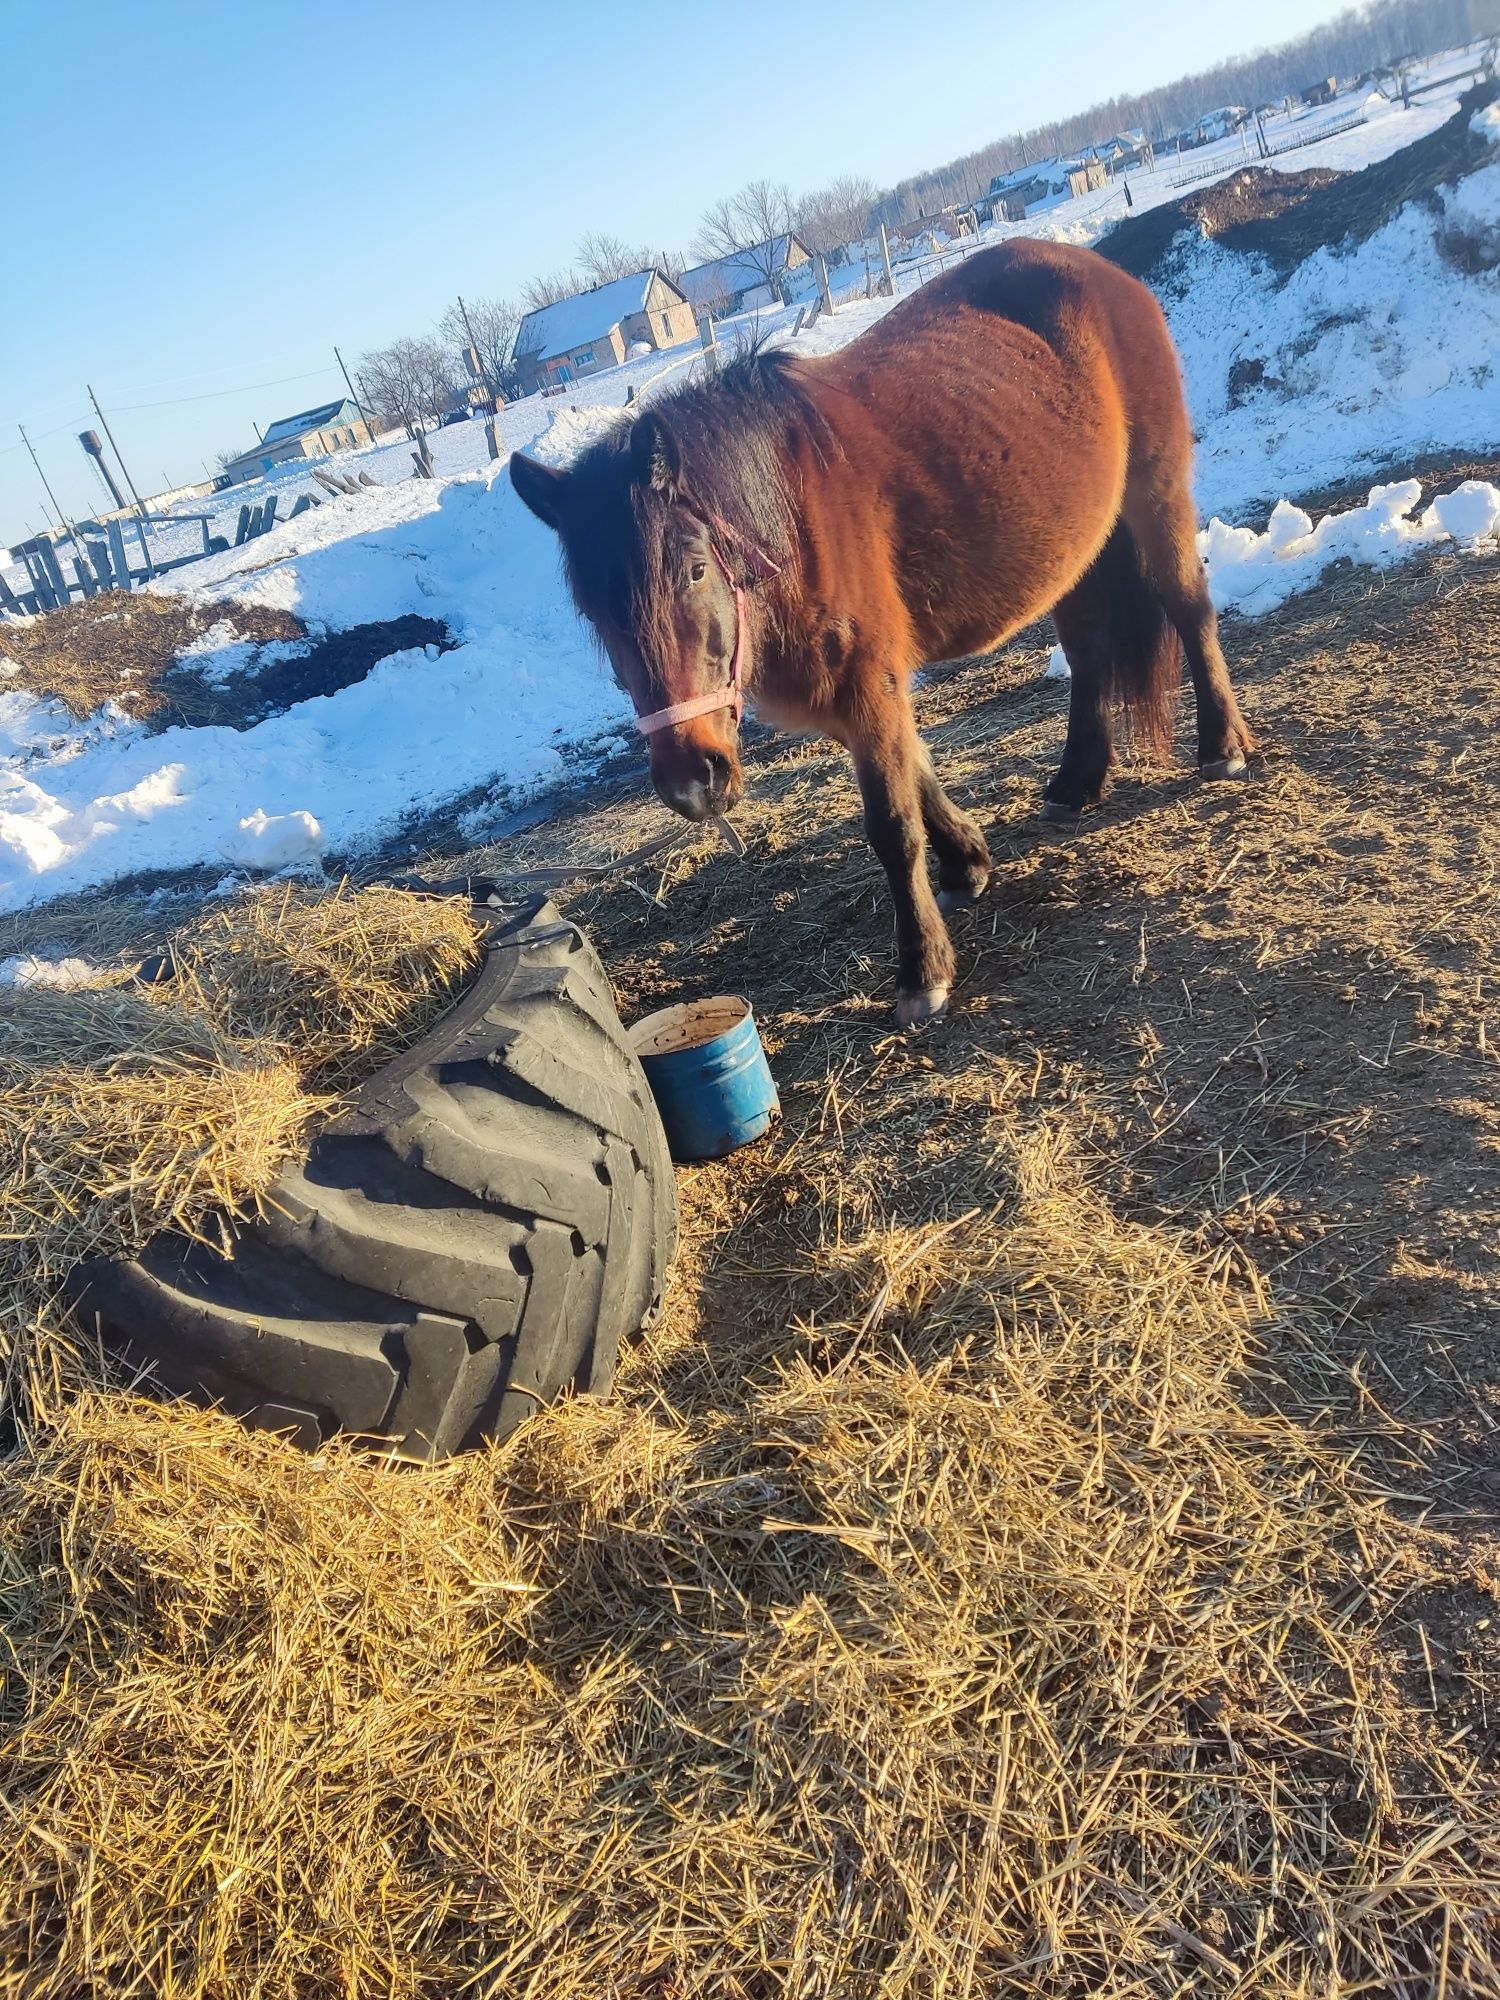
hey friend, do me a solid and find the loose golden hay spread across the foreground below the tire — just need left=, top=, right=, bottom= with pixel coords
left=0, top=1128, right=1494, bottom=2000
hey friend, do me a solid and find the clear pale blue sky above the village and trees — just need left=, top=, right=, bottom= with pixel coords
left=0, top=0, right=1344, bottom=542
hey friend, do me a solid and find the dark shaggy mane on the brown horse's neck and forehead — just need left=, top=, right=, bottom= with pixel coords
left=566, top=348, right=832, bottom=660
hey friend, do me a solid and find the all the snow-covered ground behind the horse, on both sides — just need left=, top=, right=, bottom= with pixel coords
left=0, top=54, right=1500, bottom=908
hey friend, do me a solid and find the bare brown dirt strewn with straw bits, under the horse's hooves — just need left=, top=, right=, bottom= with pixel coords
left=446, top=536, right=1500, bottom=1704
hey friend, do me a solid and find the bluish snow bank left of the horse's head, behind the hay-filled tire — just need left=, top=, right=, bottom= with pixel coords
left=0, top=472, right=630, bottom=908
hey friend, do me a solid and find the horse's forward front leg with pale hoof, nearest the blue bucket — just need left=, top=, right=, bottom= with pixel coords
left=850, top=696, right=954, bottom=1028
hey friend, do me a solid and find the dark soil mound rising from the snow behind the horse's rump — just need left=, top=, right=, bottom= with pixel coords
left=1100, top=84, right=1500, bottom=278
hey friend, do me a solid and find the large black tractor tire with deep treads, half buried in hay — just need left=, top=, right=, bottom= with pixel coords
left=72, top=898, right=678, bottom=1462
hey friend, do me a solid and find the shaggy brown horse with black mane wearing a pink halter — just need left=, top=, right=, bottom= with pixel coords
left=510, top=240, right=1254, bottom=1024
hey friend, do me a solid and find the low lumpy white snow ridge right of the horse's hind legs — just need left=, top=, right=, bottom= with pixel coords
left=1198, top=480, right=1500, bottom=612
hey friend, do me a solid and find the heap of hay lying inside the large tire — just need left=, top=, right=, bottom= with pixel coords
left=0, top=886, right=480, bottom=1418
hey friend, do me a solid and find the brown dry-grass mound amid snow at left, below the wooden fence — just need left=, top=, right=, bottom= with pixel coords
left=4, top=590, right=306, bottom=720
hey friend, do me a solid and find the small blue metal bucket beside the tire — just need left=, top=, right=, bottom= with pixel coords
left=630, top=994, right=782, bottom=1160
